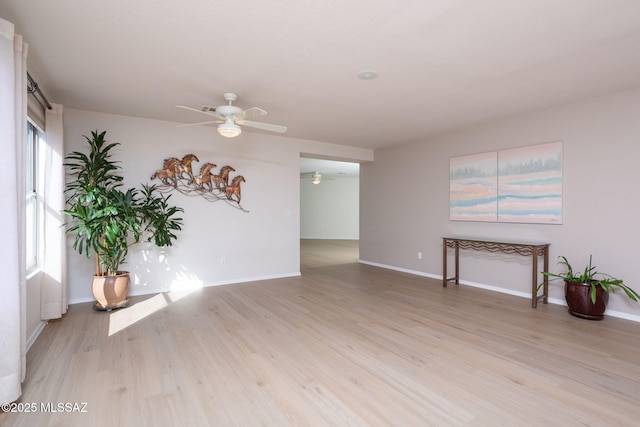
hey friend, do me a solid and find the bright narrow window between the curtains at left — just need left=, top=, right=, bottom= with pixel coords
left=25, top=122, right=44, bottom=271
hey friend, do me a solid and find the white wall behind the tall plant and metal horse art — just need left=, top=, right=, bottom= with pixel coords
left=64, top=109, right=373, bottom=303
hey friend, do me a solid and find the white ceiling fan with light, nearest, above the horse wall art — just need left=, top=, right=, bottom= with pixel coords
left=176, top=92, right=287, bottom=138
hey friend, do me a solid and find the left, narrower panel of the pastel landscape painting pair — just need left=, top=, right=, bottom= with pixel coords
left=449, top=151, right=498, bottom=222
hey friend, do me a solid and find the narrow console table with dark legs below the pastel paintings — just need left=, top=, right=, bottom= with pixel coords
left=442, top=237, right=549, bottom=308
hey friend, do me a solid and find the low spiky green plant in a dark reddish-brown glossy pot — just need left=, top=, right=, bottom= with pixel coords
left=542, top=256, right=640, bottom=320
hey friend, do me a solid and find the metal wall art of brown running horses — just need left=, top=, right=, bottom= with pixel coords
left=151, top=154, right=249, bottom=212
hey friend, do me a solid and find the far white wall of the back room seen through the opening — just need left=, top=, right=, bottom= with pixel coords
left=300, top=177, right=360, bottom=240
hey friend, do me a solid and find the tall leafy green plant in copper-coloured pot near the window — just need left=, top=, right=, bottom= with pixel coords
left=63, top=131, right=183, bottom=310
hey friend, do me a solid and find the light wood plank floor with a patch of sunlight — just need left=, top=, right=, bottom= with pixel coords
left=0, top=240, right=640, bottom=427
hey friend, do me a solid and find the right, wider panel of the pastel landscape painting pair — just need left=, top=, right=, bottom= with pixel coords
left=498, top=142, right=562, bottom=224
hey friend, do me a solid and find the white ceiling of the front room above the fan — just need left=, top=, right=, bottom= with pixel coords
left=0, top=0, right=640, bottom=154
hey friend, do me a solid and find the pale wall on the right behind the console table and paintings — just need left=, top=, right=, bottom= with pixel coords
left=360, top=89, right=640, bottom=320
